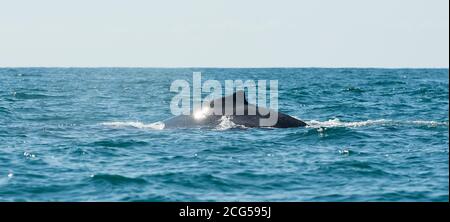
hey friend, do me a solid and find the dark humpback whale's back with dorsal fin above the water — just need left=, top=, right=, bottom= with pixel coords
left=163, top=90, right=307, bottom=128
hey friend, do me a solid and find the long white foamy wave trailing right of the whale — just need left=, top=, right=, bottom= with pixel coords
left=306, top=118, right=448, bottom=128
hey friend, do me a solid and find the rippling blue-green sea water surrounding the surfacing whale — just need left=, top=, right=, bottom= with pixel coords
left=0, top=68, right=449, bottom=201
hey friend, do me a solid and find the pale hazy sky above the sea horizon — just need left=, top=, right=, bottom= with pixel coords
left=0, top=0, right=449, bottom=68
